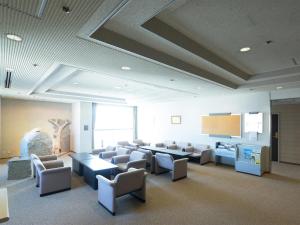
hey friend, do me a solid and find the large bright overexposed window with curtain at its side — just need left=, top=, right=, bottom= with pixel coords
left=93, top=104, right=135, bottom=149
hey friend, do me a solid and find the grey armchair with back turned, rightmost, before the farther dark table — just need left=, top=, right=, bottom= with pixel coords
left=155, top=153, right=188, bottom=181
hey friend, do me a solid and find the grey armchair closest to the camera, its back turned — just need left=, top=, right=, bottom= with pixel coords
left=96, top=168, right=146, bottom=215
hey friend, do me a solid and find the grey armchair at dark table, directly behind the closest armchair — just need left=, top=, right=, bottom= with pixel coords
left=111, top=151, right=146, bottom=172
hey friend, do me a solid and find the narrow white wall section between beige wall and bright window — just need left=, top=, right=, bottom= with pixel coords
left=71, top=102, right=93, bottom=152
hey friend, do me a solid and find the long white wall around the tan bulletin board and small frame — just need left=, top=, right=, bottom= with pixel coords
left=138, top=93, right=270, bottom=146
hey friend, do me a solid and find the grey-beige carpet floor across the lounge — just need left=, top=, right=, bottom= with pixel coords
left=0, top=156, right=300, bottom=225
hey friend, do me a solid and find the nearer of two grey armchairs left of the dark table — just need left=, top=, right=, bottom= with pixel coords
left=33, top=159, right=71, bottom=197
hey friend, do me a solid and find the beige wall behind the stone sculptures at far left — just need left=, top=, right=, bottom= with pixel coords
left=0, top=98, right=72, bottom=157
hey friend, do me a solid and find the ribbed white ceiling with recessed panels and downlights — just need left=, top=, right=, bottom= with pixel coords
left=0, top=0, right=300, bottom=104
